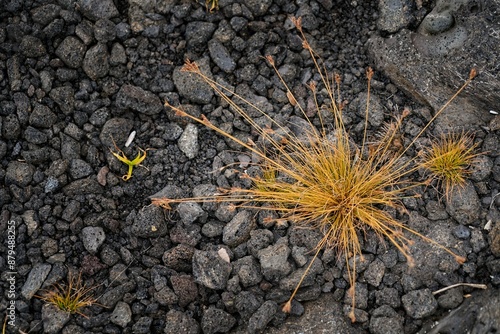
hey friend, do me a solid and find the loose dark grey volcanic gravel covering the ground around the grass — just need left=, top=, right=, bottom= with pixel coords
left=0, top=0, right=500, bottom=334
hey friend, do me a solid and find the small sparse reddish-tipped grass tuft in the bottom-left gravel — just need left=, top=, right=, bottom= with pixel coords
left=37, top=273, right=98, bottom=318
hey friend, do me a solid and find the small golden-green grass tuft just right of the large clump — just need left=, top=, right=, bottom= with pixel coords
left=420, top=133, right=478, bottom=198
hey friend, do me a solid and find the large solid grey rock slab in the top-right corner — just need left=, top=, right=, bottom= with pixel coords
left=367, top=0, right=500, bottom=130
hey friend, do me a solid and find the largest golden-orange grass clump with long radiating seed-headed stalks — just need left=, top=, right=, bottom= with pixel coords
left=153, top=18, right=474, bottom=321
